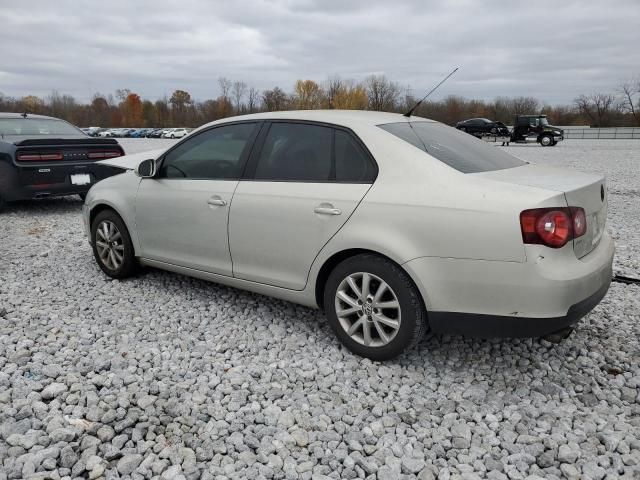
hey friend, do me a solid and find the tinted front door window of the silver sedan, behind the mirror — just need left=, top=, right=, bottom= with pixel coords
left=159, top=123, right=256, bottom=180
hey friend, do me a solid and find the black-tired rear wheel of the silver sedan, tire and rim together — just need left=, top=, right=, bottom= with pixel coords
left=323, top=254, right=427, bottom=360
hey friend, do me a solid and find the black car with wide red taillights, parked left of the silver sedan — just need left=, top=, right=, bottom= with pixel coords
left=0, top=113, right=124, bottom=210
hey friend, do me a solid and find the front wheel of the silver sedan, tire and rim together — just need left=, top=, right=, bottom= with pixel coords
left=91, top=210, right=138, bottom=279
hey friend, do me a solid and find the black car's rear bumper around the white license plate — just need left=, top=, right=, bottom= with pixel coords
left=0, top=163, right=122, bottom=201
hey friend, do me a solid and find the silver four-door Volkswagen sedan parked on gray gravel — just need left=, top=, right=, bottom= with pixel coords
left=84, top=110, right=614, bottom=360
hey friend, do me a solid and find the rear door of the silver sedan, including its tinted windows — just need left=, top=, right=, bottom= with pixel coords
left=229, top=122, right=377, bottom=290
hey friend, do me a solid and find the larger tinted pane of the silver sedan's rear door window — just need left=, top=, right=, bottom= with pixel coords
left=255, top=123, right=332, bottom=182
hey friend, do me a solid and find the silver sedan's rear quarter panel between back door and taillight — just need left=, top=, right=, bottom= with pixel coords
left=309, top=124, right=565, bottom=304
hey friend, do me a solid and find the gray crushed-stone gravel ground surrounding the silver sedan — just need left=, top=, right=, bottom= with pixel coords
left=0, top=140, right=640, bottom=480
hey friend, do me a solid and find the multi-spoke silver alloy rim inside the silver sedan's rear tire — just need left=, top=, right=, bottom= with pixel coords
left=335, top=272, right=401, bottom=347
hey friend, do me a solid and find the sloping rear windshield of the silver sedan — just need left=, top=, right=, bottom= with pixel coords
left=378, top=122, right=526, bottom=173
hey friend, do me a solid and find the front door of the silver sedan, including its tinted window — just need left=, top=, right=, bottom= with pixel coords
left=136, top=122, right=259, bottom=276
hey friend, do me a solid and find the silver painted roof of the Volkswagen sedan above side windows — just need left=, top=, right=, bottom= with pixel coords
left=209, top=110, right=434, bottom=127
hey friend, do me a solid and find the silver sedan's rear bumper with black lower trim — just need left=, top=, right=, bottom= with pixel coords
left=404, top=234, right=614, bottom=337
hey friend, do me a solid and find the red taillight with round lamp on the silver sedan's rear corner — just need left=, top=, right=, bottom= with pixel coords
left=520, top=207, right=587, bottom=248
